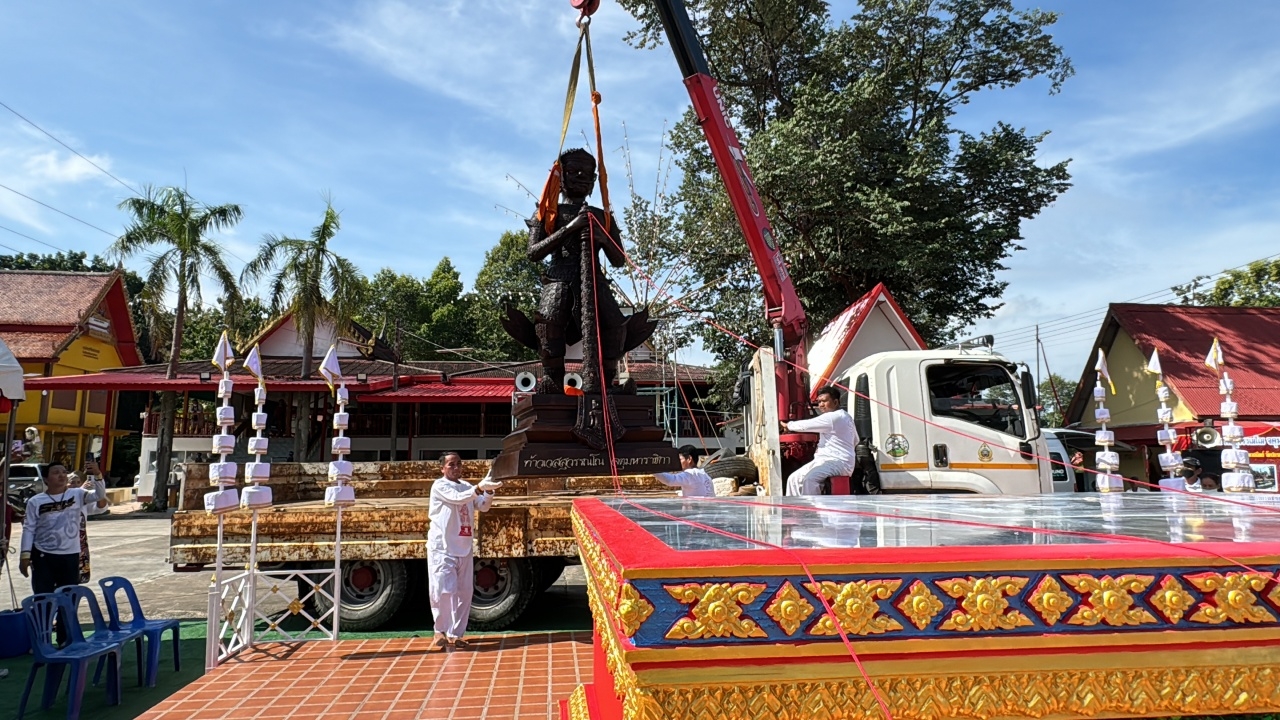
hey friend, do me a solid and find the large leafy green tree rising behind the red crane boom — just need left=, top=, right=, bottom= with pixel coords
left=620, top=0, right=1073, bottom=360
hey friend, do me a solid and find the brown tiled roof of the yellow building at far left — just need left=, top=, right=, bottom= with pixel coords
left=0, top=270, right=142, bottom=365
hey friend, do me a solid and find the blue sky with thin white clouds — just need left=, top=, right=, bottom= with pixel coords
left=0, top=0, right=1280, bottom=377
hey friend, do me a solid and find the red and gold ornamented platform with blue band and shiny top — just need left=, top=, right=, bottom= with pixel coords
left=561, top=493, right=1280, bottom=720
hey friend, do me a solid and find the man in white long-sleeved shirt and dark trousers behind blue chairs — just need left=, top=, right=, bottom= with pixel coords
left=18, top=460, right=106, bottom=593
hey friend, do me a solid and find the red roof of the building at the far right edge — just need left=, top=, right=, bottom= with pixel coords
left=1068, top=302, right=1280, bottom=419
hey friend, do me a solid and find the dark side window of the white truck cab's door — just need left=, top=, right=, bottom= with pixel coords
left=925, top=364, right=1027, bottom=438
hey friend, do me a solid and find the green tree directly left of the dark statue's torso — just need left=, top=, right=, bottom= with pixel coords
left=471, top=231, right=541, bottom=361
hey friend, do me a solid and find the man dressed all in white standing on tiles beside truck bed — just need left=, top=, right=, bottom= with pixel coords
left=426, top=452, right=502, bottom=652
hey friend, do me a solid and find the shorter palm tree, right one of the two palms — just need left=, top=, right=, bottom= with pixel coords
left=241, top=201, right=364, bottom=462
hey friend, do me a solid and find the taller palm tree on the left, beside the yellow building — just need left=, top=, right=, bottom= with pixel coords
left=110, top=186, right=243, bottom=510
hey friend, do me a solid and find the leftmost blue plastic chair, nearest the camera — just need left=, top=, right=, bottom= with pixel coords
left=18, top=593, right=120, bottom=720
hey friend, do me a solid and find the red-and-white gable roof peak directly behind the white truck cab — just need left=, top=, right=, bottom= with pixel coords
left=808, top=283, right=927, bottom=400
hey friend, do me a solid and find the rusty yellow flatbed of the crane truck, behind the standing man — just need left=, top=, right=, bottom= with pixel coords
left=169, top=460, right=673, bottom=630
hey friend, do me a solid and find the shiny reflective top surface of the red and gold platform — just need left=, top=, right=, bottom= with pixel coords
left=602, top=492, right=1280, bottom=551
